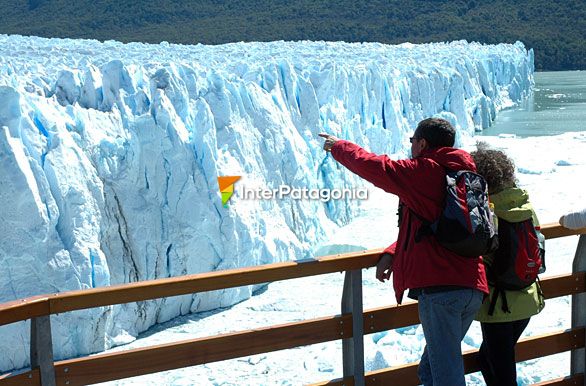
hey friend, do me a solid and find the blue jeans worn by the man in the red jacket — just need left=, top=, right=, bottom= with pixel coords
left=417, top=288, right=483, bottom=386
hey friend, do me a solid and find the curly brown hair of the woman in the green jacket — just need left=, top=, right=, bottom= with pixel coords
left=470, top=142, right=516, bottom=193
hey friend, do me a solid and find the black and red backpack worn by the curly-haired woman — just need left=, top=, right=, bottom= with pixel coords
left=486, top=218, right=545, bottom=315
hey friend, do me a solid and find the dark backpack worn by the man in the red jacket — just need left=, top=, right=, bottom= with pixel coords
left=412, top=170, right=498, bottom=257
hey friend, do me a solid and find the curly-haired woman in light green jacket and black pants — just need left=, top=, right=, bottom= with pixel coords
left=471, top=144, right=545, bottom=386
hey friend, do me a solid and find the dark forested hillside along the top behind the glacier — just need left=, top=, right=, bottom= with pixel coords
left=0, top=0, right=586, bottom=71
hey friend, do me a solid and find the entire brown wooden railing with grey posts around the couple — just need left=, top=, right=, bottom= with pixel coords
left=0, top=224, right=586, bottom=386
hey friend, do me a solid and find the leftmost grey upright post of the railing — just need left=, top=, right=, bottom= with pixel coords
left=30, top=315, right=55, bottom=386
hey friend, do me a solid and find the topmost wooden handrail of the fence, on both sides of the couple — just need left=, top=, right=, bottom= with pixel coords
left=0, top=223, right=586, bottom=326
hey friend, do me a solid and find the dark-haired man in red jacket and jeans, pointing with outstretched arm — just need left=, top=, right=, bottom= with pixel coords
left=320, top=118, right=488, bottom=386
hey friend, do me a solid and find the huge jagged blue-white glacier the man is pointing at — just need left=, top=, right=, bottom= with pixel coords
left=0, top=35, right=534, bottom=371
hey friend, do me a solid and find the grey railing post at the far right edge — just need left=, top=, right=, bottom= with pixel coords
left=570, top=235, right=586, bottom=386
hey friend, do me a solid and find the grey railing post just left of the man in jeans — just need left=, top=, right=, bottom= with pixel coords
left=342, top=269, right=364, bottom=386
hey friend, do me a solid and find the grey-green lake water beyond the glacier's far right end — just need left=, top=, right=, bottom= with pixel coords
left=477, top=71, right=586, bottom=137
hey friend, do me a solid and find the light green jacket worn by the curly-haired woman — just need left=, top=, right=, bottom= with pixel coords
left=475, top=188, right=545, bottom=323
